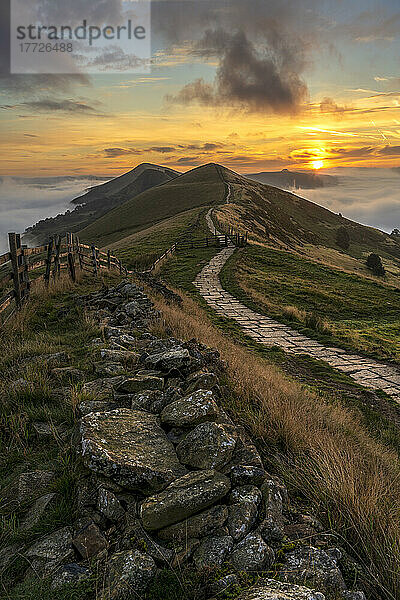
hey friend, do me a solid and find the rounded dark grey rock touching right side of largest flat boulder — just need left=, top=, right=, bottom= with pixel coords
left=176, top=422, right=237, bottom=469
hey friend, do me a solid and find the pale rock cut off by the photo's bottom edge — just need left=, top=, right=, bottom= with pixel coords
left=236, top=579, right=325, bottom=600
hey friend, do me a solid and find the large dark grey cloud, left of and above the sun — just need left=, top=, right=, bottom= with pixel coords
left=167, top=29, right=307, bottom=113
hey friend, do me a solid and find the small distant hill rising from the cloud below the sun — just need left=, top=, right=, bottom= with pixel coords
left=245, top=169, right=339, bottom=190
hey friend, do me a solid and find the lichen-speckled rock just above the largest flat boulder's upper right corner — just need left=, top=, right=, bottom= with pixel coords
left=161, top=390, right=219, bottom=427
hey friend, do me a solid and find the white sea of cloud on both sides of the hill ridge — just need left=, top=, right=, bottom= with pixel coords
left=0, top=168, right=400, bottom=254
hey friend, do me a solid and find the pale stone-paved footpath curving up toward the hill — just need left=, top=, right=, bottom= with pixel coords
left=193, top=211, right=400, bottom=402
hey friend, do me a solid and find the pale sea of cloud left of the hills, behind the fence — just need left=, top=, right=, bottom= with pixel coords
left=0, top=177, right=109, bottom=254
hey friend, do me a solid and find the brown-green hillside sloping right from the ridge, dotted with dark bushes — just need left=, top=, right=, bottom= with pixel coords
left=217, top=164, right=400, bottom=269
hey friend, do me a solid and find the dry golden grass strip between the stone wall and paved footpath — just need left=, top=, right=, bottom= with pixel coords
left=148, top=288, right=400, bottom=598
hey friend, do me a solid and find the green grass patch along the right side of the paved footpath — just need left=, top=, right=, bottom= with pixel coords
left=221, top=246, right=400, bottom=361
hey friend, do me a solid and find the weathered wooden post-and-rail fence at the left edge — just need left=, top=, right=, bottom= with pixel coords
left=0, top=233, right=128, bottom=326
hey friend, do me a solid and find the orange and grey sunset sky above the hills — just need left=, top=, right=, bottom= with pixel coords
left=0, top=0, right=400, bottom=177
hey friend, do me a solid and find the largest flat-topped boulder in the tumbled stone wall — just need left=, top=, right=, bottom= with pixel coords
left=81, top=408, right=185, bottom=494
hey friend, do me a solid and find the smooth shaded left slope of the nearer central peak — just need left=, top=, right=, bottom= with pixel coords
left=80, top=164, right=225, bottom=246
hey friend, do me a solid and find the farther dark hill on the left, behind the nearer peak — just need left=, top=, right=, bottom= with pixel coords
left=24, top=163, right=180, bottom=244
